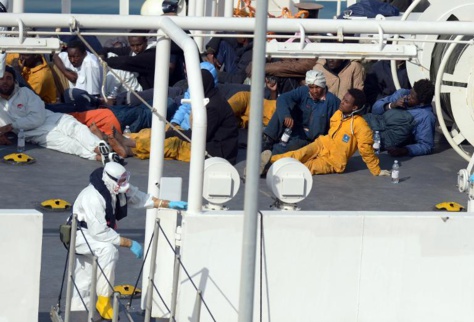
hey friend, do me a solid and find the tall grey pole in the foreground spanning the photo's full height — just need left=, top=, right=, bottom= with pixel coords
left=238, top=0, right=268, bottom=322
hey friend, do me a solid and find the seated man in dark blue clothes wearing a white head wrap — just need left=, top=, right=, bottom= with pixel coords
left=262, top=70, right=340, bottom=154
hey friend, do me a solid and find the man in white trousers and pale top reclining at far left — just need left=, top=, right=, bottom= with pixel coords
left=0, top=66, right=120, bottom=160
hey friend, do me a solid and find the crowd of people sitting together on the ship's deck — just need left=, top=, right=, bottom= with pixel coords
left=0, top=24, right=435, bottom=175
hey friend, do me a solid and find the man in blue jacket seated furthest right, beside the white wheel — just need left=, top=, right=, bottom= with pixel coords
left=372, top=79, right=436, bottom=156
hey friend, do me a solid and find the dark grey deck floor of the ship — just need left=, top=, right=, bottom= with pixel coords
left=0, top=130, right=472, bottom=322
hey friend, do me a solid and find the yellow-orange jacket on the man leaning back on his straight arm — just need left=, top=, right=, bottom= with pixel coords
left=316, top=111, right=380, bottom=176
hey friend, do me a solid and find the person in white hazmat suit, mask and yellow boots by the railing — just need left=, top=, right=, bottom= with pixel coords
left=69, top=162, right=187, bottom=319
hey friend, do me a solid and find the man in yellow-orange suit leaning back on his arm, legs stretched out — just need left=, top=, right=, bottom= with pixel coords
left=260, top=88, right=390, bottom=176
